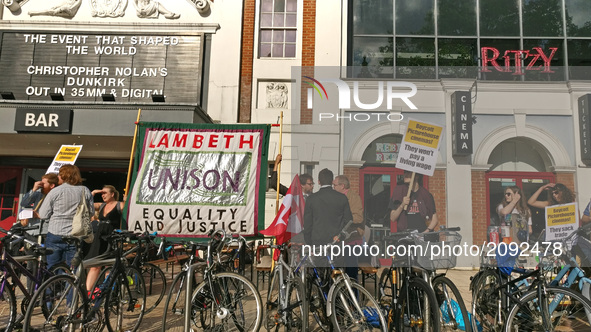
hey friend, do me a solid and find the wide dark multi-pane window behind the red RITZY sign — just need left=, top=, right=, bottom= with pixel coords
left=347, top=0, right=591, bottom=81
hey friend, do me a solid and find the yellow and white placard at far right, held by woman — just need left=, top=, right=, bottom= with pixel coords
left=546, top=202, right=579, bottom=241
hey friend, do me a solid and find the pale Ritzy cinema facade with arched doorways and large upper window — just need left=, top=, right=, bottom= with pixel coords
left=239, top=0, right=591, bottom=265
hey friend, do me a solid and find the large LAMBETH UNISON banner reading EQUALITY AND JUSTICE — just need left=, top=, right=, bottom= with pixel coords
left=127, top=123, right=270, bottom=237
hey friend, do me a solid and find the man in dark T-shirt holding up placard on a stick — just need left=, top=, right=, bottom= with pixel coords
left=388, top=171, right=439, bottom=233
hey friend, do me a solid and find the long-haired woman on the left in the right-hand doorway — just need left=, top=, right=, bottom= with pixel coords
left=497, top=186, right=532, bottom=243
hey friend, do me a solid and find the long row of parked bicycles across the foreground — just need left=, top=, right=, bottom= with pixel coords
left=0, top=222, right=591, bottom=331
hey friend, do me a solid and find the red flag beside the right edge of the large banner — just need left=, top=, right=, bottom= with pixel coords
left=260, top=175, right=304, bottom=258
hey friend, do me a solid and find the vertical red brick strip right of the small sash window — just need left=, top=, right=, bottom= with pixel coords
left=300, top=0, right=316, bottom=124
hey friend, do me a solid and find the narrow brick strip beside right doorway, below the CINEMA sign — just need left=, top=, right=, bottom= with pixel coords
left=472, top=171, right=489, bottom=243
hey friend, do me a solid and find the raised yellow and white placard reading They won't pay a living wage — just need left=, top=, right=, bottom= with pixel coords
left=396, top=120, right=443, bottom=176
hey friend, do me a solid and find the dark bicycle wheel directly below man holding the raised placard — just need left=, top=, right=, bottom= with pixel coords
left=394, top=278, right=441, bottom=332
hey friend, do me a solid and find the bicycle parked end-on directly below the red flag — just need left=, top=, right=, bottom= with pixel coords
left=257, top=244, right=308, bottom=331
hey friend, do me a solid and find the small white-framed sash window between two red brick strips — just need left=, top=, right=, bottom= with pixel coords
left=259, top=0, right=297, bottom=58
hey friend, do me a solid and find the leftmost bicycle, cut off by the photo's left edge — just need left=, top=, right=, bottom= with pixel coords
left=0, top=226, right=69, bottom=331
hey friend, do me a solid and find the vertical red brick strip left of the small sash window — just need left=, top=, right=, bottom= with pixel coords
left=238, top=0, right=256, bottom=123
